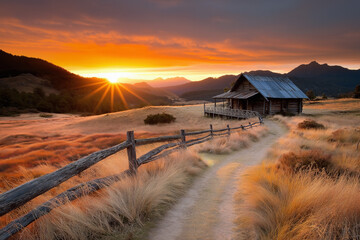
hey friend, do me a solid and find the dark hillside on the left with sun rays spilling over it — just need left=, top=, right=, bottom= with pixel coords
left=0, top=50, right=177, bottom=115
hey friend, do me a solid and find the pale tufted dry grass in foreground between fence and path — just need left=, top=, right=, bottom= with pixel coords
left=19, top=151, right=206, bottom=239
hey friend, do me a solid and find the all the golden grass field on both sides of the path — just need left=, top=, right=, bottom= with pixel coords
left=0, top=99, right=360, bottom=239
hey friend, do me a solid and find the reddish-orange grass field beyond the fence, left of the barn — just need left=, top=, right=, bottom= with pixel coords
left=0, top=105, right=257, bottom=183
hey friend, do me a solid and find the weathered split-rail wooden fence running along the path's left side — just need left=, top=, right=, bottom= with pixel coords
left=0, top=118, right=263, bottom=240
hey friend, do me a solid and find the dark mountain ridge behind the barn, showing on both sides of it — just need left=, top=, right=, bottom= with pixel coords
left=166, top=61, right=360, bottom=100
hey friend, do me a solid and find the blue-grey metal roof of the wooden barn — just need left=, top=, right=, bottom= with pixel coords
left=230, top=74, right=308, bottom=99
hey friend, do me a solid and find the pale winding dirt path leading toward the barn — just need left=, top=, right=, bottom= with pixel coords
left=149, top=120, right=286, bottom=240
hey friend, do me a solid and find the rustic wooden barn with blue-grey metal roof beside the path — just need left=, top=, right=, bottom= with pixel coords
left=213, top=74, right=308, bottom=115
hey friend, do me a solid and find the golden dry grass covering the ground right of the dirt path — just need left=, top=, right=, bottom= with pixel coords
left=236, top=114, right=360, bottom=239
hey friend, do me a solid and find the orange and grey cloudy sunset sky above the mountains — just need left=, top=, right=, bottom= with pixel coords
left=0, top=0, right=360, bottom=80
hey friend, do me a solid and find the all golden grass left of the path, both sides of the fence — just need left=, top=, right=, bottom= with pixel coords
left=0, top=105, right=267, bottom=239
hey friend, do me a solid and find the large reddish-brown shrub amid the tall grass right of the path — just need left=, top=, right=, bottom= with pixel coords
left=279, top=149, right=333, bottom=173
